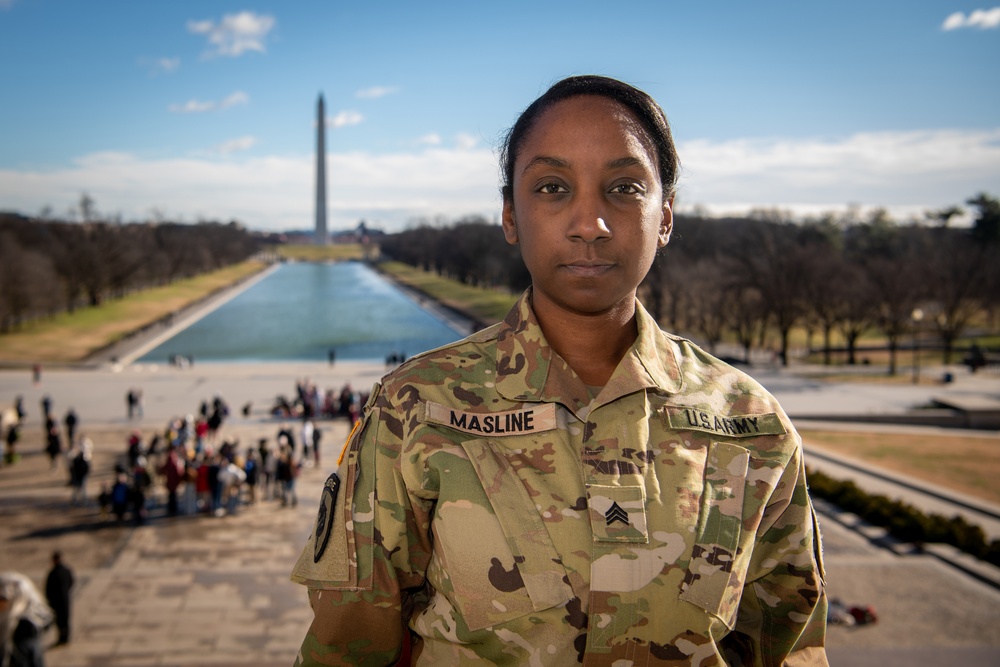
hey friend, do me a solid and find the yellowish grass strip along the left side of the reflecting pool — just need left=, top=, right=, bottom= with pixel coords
left=0, top=262, right=266, bottom=364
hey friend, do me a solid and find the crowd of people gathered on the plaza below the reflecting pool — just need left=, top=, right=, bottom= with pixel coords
left=2, top=379, right=367, bottom=524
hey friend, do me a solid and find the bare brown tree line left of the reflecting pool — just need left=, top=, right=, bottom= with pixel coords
left=0, top=210, right=257, bottom=331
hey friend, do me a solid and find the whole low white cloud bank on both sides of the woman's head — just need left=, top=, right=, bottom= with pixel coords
left=0, top=127, right=1000, bottom=230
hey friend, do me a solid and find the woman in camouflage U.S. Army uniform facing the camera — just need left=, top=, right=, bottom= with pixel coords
left=292, top=76, right=827, bottom=667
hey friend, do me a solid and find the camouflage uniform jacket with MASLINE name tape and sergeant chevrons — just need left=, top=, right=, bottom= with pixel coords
left=292, top=290, right=827, bottom=667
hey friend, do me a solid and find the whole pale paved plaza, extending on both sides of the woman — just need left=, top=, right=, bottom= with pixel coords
left=0, top=362, right=1000, bottom=667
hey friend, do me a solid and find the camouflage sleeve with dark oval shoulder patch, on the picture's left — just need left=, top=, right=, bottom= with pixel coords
left=292, top=390, right=430, bottom=666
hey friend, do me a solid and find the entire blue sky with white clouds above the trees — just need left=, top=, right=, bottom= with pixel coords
left=0, top=0, right=1000, bottom=230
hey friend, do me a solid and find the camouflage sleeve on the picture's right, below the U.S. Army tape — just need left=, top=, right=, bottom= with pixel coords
left=726, top=431, right=828, bottom=667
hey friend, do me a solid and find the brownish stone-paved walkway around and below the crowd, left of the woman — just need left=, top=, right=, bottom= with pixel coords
left=0, top=414, right=347, bottom=667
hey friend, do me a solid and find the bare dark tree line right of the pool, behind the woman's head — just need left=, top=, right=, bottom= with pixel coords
left=382, top=193, right=1000, bottom=374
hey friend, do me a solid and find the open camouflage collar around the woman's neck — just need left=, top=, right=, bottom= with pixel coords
left=496, top=288, right=681, bottom=414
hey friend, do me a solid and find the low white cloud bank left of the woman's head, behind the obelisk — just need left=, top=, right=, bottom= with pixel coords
left=0, top=149, right=500, bottom=229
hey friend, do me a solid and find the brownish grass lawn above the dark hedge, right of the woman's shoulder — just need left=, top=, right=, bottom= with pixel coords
left=800, top=431, right=1000, bottom=503
